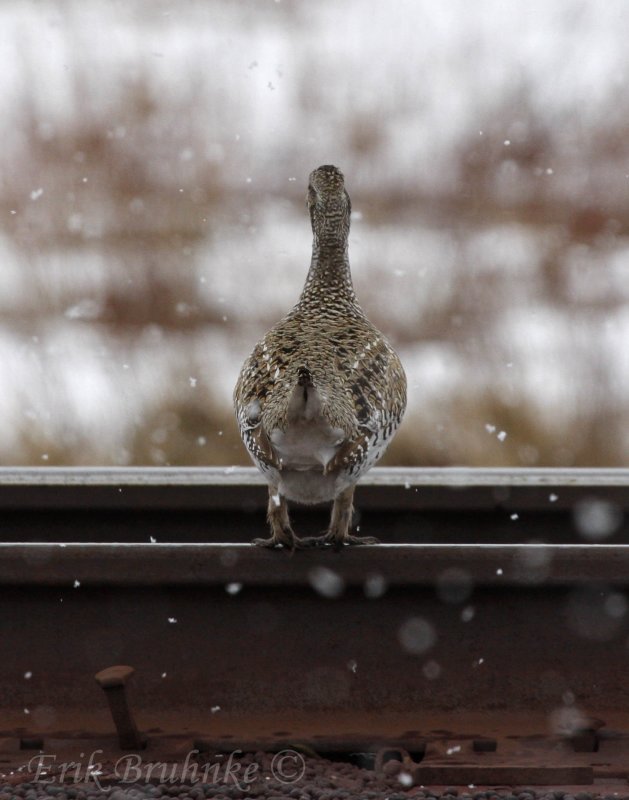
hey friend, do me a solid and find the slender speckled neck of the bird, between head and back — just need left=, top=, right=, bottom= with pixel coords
left=301, top=234, right=356, bottom=303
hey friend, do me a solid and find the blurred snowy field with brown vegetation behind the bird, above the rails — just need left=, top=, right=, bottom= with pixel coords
left=0, top=0, right=629, bottom=466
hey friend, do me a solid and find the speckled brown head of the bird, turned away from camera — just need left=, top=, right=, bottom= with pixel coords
left=308, top=164, right=352, bottom=244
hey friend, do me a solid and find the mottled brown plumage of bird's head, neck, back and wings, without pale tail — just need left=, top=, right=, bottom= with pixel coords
left=234, top=166, right=406, bottom=488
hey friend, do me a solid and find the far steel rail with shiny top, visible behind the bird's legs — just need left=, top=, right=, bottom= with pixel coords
left=0, top=467, right=629, bottom=544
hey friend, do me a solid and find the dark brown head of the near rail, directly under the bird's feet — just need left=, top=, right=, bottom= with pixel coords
left=0, top=543, right=629, bottom=588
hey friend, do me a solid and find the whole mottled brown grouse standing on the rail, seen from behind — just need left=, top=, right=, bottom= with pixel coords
left=234, top=164, right=406, bottom=551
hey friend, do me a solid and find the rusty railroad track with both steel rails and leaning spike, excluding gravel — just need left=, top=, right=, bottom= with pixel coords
left=0, top=469, right=629, bottom=796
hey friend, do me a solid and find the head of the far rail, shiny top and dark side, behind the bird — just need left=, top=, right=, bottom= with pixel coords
left=0, top=467, right=629, bottom=510
